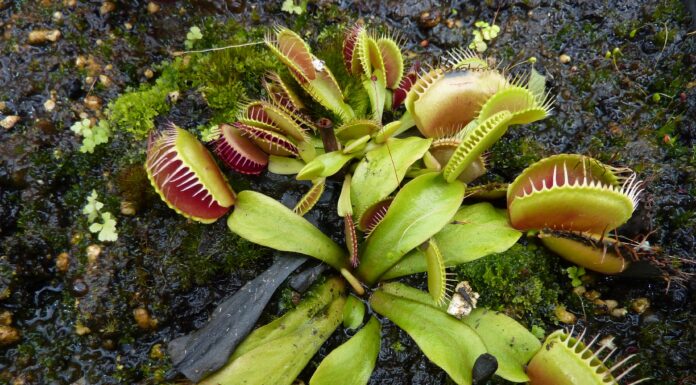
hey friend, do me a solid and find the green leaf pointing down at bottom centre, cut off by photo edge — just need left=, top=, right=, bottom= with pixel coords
left=309, top=317, right=381, bottom=385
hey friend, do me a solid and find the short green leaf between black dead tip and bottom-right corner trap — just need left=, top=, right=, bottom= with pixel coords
left=462, top=308, right=541, bottom=382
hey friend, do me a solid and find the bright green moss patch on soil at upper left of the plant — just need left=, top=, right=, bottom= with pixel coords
left=108, top=20, right=278, bottom=139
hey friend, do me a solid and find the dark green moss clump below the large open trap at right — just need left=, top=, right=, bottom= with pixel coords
left=456, top=244, right=566, bottom=325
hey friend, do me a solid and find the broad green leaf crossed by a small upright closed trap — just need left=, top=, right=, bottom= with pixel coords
left=382, top=202, right=522, bottom=279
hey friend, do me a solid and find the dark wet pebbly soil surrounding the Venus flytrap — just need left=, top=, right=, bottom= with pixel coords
left=0, top=0, right=696, bottom=385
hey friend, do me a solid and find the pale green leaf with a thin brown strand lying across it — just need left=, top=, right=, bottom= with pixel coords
left=350, top=137, right=432, bottom=219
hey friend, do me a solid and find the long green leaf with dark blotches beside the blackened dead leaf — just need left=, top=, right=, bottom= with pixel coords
left=204, top=278, right=345, bottom=385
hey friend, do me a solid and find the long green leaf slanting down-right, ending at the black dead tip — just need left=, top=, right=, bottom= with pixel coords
left=370, top=289, right=486, bottom=385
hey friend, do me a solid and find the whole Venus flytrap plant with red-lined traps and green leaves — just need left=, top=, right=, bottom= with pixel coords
left=140, top=24, right=652, bottom=385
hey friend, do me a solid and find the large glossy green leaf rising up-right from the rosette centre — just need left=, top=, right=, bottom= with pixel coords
left=353, top=173, right=465, bottom=285
